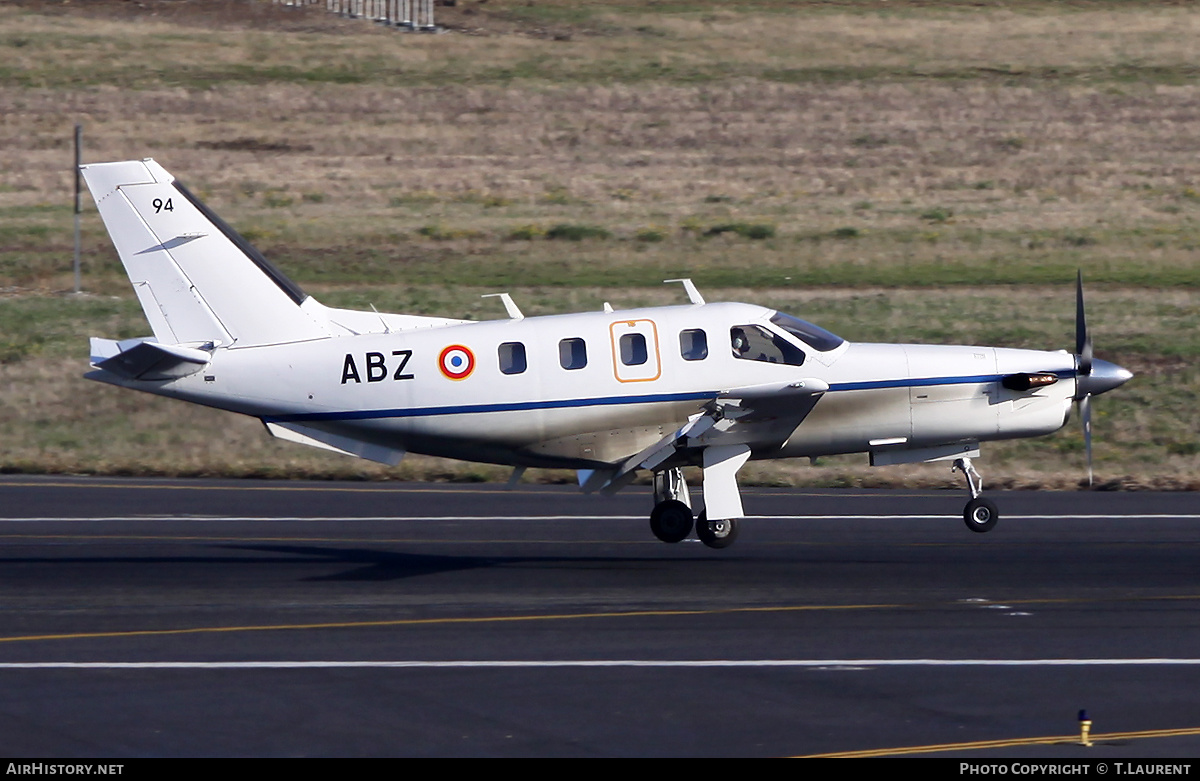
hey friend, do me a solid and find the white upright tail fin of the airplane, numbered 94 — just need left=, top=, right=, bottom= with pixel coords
left=80, top=160, right=329, bottom=347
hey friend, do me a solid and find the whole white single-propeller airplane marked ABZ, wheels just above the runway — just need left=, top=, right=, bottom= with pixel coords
left=82, top=160, right=1132, bottom=548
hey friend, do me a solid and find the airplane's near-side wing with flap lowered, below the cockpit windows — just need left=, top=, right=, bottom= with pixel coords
left=580, top=379, right=829, bottom=493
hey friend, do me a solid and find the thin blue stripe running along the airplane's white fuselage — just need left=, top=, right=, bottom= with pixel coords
left=263, top=371, right=1075, bottom=423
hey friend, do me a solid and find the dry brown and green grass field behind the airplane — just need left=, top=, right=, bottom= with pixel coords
left=0, top=0, right=1200, bottom=488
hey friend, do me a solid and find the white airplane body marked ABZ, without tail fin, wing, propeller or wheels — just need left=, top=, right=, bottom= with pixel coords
left=97, top=304, right=1075, bottom=468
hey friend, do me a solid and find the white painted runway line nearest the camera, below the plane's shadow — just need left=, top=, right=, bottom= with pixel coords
left=7, top=657, right=1200, bottom=671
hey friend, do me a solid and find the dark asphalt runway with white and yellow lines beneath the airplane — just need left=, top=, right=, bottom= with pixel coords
left=0, top=476, right=1200, bottom=759
